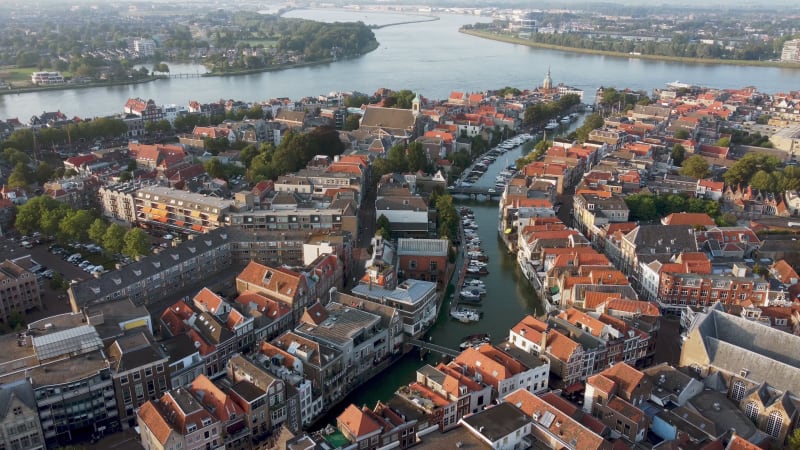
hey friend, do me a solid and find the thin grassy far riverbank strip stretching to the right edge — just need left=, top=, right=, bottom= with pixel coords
left=458, top=28, right=800, bottom=69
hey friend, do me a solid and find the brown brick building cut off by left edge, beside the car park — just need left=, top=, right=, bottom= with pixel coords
left=0, top=260, right=42, bottom=324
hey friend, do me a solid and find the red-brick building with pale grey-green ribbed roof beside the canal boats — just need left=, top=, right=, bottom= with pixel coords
left=397, top=238, right=450, bottom=286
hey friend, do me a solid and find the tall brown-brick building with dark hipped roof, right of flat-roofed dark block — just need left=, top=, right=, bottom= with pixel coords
left=108, top=328, right=172, bottom=429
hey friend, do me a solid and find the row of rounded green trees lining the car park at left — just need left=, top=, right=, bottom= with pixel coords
left=14, top=195, right=150, bottom=257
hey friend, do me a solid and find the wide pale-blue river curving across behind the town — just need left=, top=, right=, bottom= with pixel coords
left=0, top=9, right=800, bottom=121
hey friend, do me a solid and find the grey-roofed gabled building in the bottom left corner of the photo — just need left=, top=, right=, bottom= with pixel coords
left=0, top=380, right=45, bottom=450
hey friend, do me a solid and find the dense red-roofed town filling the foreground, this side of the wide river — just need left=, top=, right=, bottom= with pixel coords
left=0, top=59, right=800, bottom=450
